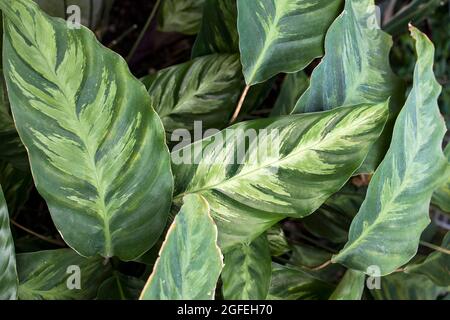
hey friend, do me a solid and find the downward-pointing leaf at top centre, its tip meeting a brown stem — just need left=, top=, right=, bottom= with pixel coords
left=237, top=0, right=342, bottom=85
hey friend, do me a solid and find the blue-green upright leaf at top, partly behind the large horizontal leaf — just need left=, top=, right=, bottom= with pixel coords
left=293, top=0, right=404, bottom=173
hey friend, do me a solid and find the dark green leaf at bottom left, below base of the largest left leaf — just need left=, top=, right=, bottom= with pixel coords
left=16, top=250, right=111, bottom=300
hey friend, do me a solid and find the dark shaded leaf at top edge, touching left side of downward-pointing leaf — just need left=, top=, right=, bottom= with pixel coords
left=192, top=0, right=239, bottom=58
